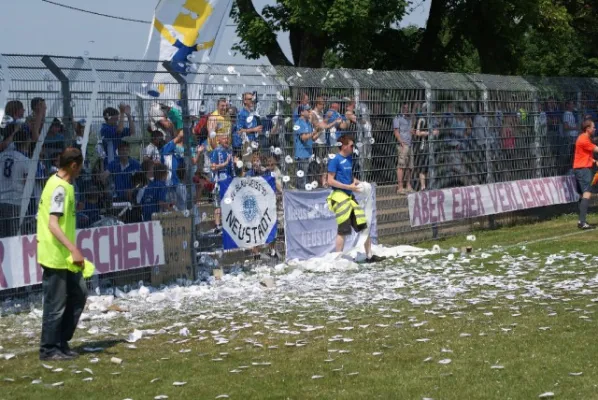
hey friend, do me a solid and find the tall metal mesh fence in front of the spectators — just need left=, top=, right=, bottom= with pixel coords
left=0, top=55, right=598, bottom=304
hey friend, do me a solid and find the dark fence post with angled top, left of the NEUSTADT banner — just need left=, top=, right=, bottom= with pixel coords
left=162, top=61, right=197, bottom=280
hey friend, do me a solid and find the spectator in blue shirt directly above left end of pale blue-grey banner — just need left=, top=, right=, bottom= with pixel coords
left=293, top=104, right=318, bottom=189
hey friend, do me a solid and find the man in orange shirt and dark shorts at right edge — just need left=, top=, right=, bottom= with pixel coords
left=573, top=120, right=598, bottom=229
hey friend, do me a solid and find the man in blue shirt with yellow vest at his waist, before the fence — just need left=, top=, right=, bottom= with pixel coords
left=327, top=135, right=384, bottom=263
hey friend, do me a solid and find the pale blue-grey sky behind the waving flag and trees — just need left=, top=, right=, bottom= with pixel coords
left=0, top=0, right=430, bottom=64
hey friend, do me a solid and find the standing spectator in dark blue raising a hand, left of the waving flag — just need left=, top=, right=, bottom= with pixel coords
left=100, top=104, right=135, bottom=163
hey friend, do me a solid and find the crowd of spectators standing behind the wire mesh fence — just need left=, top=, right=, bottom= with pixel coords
left=0, top=92, right=595, bottom=237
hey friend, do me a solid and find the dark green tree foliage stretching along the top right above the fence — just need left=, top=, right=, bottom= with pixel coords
left=233, top=0, right=598, bottom=76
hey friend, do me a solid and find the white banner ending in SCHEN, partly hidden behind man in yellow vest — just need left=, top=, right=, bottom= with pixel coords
left=0, top=221, right=165, bottom=290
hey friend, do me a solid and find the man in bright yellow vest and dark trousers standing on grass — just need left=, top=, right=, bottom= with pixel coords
left=37, top=147, right=87, bottom=361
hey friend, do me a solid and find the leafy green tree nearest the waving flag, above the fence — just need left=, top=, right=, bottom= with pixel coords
left=232, top=0, right=409, bottom=68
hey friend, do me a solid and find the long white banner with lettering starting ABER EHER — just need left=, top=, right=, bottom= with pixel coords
left=408, top=175, right=579, bottom=227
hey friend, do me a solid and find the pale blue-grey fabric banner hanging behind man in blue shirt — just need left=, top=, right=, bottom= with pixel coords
left=283, top=185, right=378, bottom=260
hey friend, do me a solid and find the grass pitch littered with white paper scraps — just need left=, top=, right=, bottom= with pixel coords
left=0, top=217, right=598, bottom=400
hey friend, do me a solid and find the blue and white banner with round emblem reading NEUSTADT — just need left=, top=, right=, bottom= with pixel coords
left=218, top=176, right=277, bottom=250
